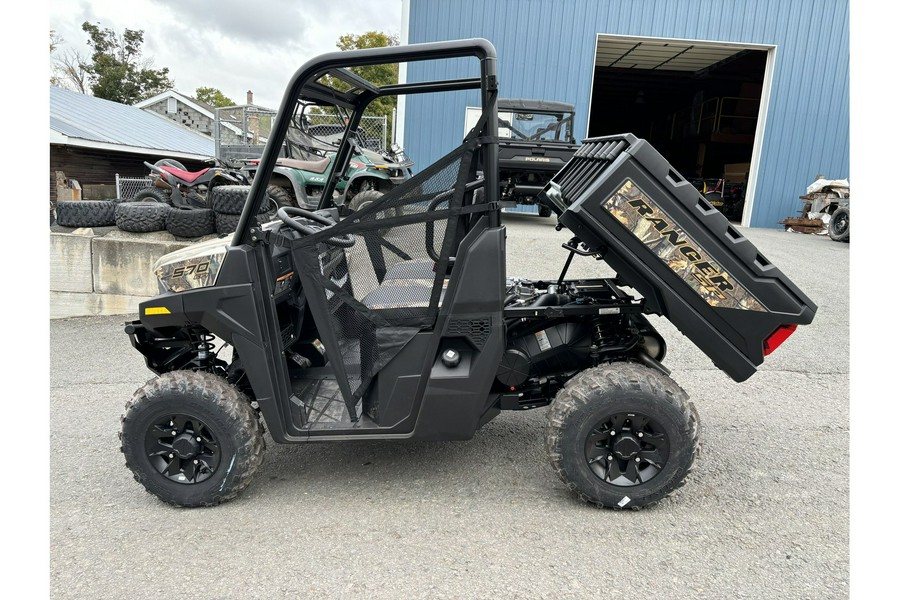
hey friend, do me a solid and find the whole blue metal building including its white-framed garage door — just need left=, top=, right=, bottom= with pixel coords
left=398, top=0, right=850, bottom=227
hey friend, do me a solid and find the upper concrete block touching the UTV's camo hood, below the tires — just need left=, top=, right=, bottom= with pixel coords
left=92, top=235, right=189, bottom=296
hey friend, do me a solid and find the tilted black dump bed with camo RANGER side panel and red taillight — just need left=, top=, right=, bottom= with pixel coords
left=544, top=134, right=816, bottom=381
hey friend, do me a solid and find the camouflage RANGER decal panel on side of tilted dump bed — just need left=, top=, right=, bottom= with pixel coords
left=603, top=179, right=766, bottom=312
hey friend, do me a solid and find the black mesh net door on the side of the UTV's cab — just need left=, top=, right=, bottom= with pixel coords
left=294, top=143, right=476, bottom=410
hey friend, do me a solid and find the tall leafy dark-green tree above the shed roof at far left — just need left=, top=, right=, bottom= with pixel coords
left=81, top=21, right=174, bottom=104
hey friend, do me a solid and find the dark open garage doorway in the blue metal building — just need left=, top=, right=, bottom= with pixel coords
left=587, top=36, right=774, bottom=224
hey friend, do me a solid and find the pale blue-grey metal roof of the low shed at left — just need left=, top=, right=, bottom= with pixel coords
left=50, top=87, right=215, bottom=158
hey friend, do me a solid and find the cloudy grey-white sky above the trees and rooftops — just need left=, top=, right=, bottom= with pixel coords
left=49, top=0, right=401, bottom=108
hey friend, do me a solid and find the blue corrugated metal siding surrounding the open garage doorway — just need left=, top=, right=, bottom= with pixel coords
left=404, top=0, right=850, bottom=227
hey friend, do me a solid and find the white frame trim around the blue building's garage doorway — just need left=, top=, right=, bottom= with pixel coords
left=584, top=33, right=778, bottom=227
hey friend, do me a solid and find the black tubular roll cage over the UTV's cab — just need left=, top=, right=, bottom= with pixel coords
left=232, top=38, right=499, bottom=246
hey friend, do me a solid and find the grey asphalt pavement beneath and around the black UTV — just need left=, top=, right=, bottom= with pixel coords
left=49, top=215, right=850, bottom=600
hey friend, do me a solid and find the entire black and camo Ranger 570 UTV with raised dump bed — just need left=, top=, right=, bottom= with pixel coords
left=121, top=39, right=816, bottom=509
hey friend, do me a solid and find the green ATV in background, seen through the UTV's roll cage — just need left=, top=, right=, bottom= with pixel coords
left=243, top=105, right=413, bottom=210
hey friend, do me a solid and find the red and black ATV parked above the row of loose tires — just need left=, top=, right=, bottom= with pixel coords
left=134, top=158, right=250, bottom=208
